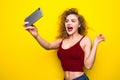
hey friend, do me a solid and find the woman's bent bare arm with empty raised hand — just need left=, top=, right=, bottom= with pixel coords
left=84, top=35, right=105, bottom=69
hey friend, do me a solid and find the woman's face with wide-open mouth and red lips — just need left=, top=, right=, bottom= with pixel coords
left=65, top=14, right=80, bottom=35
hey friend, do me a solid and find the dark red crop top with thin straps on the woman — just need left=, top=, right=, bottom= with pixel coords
left=57, top=36, right=84, bottom=72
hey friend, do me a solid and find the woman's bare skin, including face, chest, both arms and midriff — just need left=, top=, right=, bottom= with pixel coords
left=24, top=14, right=105, bottom=80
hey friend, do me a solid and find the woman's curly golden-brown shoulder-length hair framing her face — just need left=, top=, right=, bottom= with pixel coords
left=57, top=8, right=87, bottom=39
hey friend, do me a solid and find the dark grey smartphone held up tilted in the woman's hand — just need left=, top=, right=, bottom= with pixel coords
left=24, top=8, right=43, bottom=26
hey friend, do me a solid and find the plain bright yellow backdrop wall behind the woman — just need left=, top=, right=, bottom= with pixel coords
left=0, top=0, right=120, bottom=80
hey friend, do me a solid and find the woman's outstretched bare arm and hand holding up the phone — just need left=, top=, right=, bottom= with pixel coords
left=24, top=22, right=62, bottom=50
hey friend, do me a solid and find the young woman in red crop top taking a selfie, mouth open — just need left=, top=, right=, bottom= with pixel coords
left=24, top=8, right=105, bottom=80
